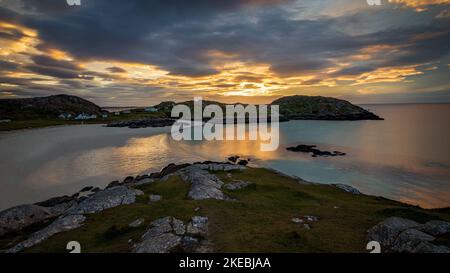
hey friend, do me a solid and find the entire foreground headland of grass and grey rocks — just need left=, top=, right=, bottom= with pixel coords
left=0, top=160, right=450, bottom=253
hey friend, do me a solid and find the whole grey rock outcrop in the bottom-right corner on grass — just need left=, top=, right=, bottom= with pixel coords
left=367, top=217, right=450, bottom=253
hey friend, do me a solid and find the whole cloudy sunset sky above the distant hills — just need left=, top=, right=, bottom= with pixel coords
left=0, top=0, right=450, bottom=106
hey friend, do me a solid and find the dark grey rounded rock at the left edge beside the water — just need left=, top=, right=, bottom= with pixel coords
left=0, top=205, right=55, bottom=236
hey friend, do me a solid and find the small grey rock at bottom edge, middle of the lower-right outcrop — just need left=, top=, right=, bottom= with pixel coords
left=390, top=229, right=435, bottom=253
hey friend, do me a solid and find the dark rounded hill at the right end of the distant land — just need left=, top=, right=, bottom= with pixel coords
left=272, top=96, right=382, bottom=120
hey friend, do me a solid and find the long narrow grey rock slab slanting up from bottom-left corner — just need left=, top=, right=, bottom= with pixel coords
left=7, top=215, right=86, bottom=253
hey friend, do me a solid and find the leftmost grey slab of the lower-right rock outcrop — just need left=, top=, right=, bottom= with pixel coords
left=368, top=217, right=420, bottom=247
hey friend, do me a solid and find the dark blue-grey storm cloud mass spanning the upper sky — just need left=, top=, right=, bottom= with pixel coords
left=0, top=0, right=450, bottom=81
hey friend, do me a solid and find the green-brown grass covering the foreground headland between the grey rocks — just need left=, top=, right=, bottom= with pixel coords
left=0, top=168, right=450, bottom=252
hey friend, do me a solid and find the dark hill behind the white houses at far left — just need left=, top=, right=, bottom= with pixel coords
left=0, top=95, right=101, bottom=120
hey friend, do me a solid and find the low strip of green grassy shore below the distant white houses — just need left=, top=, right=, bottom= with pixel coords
left=0, top=111, right=166, bottom=131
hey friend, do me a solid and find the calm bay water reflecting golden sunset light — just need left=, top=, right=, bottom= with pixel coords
left=0, top=104, right=450, bottom=209
